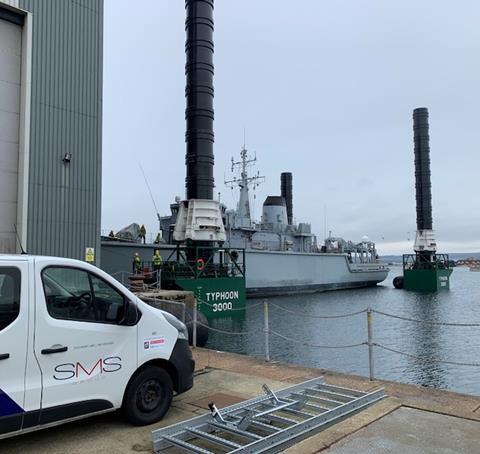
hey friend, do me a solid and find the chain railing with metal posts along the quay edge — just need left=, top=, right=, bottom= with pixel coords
left=188, top=301, right=480, bottom=380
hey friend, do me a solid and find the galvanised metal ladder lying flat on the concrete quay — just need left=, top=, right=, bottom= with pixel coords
left=152, top=377, right=385, bottom=454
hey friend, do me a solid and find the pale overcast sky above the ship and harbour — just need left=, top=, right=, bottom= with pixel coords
left=102, top=0, right=480, bottom=254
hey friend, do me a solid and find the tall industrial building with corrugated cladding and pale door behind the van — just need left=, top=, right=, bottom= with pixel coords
left=0, top=0, right=103, bottom=264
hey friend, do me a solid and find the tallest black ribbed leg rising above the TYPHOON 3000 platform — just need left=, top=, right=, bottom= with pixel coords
left=185, top=0, right=214, bottom=200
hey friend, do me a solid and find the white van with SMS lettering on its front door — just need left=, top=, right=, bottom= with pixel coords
left=0, top=255, right=195, bottom=439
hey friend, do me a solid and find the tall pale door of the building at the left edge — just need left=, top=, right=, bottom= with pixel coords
left=0, top=19, right=22, bottom=253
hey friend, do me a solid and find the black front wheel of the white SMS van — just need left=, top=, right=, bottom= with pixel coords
left=123, top=366, right=173, bottom=426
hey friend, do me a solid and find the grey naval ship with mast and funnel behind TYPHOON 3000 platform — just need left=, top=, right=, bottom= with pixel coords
left=160, top=146, right=389, bottom=297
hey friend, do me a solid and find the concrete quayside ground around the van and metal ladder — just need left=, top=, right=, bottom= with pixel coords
left=0, top=349, right=480, bottom=454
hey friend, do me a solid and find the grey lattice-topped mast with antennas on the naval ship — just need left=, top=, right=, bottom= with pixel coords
left=225, top=144, right=265, bottom=228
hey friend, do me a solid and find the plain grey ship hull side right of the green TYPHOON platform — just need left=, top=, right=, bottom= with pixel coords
left=245, top=250, right=389, bottom=297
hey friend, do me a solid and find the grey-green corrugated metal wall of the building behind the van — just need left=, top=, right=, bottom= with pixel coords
left=19, top=0, right=103, bottom=264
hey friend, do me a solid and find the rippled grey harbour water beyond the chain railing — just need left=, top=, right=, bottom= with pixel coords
left=207, top=267, right=480, bottom=395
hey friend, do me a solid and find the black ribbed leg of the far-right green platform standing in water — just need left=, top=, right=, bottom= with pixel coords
left=413, top=107, right=432, bottom=230
